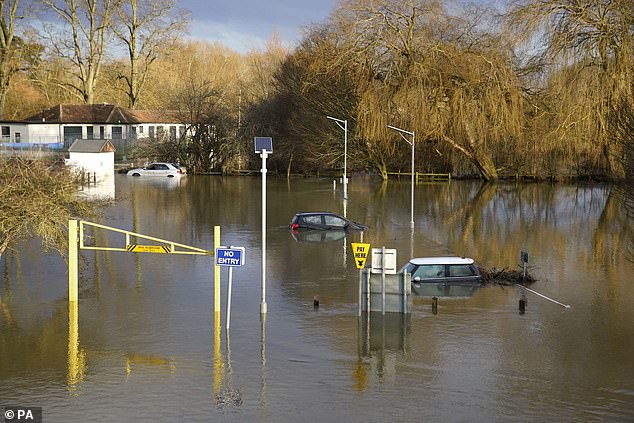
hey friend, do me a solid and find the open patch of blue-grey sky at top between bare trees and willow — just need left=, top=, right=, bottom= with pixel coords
left=178, top=0, right=337, bottom=53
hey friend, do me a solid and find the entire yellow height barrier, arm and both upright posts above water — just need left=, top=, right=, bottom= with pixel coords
left=68, top=220, right=220, bottom=304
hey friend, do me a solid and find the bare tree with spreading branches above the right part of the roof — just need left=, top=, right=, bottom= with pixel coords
left=114, top=0, right=188, bottom=109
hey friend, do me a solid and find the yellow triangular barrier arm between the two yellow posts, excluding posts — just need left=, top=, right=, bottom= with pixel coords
left=79, top=220, right=214, bottom=256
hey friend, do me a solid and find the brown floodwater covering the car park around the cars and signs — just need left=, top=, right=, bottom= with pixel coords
left=0, top=175, right=634, bottom=422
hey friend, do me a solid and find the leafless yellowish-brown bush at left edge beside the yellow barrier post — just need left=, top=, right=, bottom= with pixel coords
left=0, top=157, right=95, bottom=255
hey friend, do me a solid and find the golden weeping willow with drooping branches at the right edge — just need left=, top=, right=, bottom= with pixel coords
left=507, top=0, right=634, bottom=176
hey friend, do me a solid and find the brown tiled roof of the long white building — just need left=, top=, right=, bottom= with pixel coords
left=23, top=103, right=181, bottom=125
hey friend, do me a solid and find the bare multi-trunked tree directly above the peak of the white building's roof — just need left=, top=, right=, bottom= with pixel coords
left=42, top=0, right=119, bottom=104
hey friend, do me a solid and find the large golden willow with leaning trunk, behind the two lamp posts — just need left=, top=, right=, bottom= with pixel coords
left=320, top=0, right=524, bottom=180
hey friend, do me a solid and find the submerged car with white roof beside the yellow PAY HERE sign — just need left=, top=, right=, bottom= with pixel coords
left=401, top=257, right=482, bottom=296
